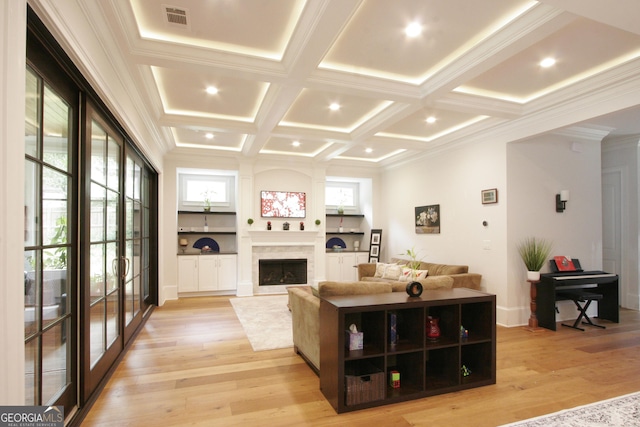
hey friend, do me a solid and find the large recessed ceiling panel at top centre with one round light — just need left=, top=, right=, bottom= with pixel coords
left=320, top=0, right=533, bottom=83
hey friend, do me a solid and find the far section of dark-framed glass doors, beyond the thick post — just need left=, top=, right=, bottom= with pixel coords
left=80, top=102, right=155, bottom=400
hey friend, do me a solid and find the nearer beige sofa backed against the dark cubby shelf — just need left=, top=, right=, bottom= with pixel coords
left=287, top=276, right=453, bottom=373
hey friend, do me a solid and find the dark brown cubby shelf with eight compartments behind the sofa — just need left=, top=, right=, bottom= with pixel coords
left=320, top=288, right=496, bottom=413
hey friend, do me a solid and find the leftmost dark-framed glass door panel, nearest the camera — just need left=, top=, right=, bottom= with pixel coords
left=24, top=67, right=77, bottom=413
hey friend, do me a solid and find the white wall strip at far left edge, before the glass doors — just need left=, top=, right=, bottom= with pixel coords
left=0, top=0, right=27, bottom=405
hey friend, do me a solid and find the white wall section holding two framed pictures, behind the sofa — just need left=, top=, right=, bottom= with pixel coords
left=381, top=141, right=508, bottom=307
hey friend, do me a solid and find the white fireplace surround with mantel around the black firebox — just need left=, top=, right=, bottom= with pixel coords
left=249, top=230, right=318, bottom=295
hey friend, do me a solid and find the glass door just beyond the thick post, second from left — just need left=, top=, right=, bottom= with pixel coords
left=81, top=102, right=124, bottom=401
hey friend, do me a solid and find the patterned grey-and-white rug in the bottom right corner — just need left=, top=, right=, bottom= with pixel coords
left=503, top=392, right=640, bottom=427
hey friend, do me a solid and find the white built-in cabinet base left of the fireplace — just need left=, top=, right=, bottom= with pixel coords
left=178, top=254, right=238, bottom=293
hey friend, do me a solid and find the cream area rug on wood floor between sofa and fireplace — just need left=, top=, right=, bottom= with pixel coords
left=229, top=295, right=293, bottom=351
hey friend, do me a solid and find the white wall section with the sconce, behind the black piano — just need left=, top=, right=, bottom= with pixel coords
left=508, top=135, right=602, bottom=325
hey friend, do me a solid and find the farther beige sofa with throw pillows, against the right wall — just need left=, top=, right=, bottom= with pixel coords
left=358, top=258, right=482, bottom=291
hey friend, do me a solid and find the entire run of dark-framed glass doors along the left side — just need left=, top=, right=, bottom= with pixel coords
left=27, top=7, right=157, bottom=414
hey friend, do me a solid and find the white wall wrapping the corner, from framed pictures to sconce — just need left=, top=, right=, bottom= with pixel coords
left=380, top=135, right=602, bottom=326
